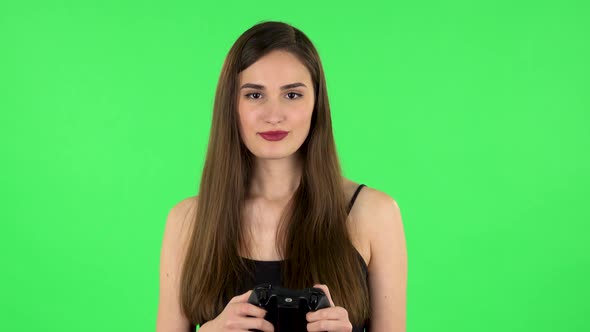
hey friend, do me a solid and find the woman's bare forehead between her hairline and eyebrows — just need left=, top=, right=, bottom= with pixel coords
left=239, top=51, right=311, bottom=87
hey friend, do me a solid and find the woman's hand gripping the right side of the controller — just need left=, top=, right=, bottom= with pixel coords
left=305, top=284, right=352, bottom=332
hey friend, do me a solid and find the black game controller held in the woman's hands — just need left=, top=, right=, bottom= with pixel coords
left=248, top=284, right=330, bottom=332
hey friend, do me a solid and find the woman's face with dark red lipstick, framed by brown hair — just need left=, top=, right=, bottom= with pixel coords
left=238, top=50, right=314, bottom=159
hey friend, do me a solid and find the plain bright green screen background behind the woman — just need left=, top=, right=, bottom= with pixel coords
left=0, top=1, right=590, bottom=332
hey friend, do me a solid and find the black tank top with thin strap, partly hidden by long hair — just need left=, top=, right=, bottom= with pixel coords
left=190, top=184, right=370, bottom=332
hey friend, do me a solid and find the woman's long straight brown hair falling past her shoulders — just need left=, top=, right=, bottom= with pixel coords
left=180, top=21, right=370, bottom=325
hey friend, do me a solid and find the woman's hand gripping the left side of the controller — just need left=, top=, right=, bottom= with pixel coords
left=203, top=290, right=274, bottom=332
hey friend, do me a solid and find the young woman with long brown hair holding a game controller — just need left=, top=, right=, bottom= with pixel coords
left=157, top=21, right=407, bottom=332
